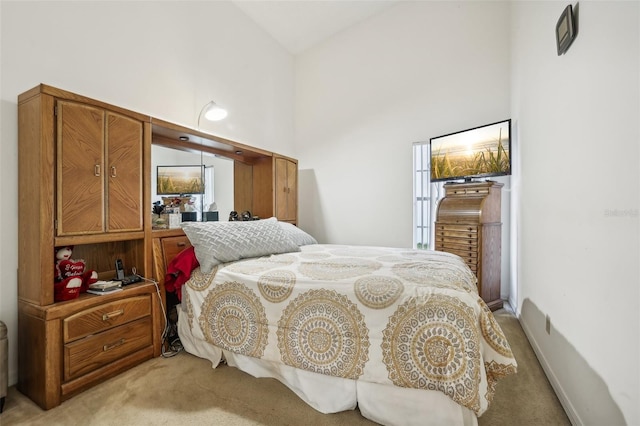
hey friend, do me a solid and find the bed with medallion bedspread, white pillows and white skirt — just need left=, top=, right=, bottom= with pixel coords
left=155, top=218, right=517, bottom=425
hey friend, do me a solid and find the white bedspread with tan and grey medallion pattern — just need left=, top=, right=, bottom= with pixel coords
left=182, top=244, right=516, bottom=415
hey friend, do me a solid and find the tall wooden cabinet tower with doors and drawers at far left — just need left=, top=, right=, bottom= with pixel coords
left=17, top=85, right=163, bottom=409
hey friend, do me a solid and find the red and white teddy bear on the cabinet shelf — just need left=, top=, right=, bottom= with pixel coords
left=54, top=246, right=98, bottom=302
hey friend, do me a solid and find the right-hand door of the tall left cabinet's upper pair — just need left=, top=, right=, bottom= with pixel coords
left=105, top=113, right=143, bottom=231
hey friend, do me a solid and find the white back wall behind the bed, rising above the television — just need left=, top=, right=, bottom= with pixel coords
left=295, top=2, right=510, bottom=252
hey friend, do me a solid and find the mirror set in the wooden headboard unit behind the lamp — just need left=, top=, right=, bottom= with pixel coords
left=151, top=145, right=234, bottom=221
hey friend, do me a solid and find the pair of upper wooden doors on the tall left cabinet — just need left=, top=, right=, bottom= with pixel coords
left=55, top=100, right=143, bottom=236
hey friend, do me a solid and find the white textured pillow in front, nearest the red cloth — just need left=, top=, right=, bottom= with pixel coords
left=182, top=218, right=300, bottom=274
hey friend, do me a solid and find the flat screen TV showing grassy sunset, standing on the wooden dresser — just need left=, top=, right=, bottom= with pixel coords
left=430, top=119, right=511, bottom=182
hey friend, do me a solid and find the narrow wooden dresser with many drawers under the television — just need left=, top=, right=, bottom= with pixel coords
left=435, top=181, right=503, bottom=310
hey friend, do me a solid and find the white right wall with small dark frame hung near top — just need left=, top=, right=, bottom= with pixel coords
left=511, top=0, right=640, bottom=425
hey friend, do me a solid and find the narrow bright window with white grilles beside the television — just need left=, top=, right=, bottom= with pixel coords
left=413, top=142, right=431, bottom=249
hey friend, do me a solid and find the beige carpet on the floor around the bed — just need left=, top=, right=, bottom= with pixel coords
left=0, top=310, right=570, bottom=426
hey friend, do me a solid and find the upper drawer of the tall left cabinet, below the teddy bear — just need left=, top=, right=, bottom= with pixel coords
left=62, top=295, right=151, bottom=343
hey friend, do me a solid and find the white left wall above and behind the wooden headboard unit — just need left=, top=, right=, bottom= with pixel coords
left=0, top=0, right=295, bottom=383
